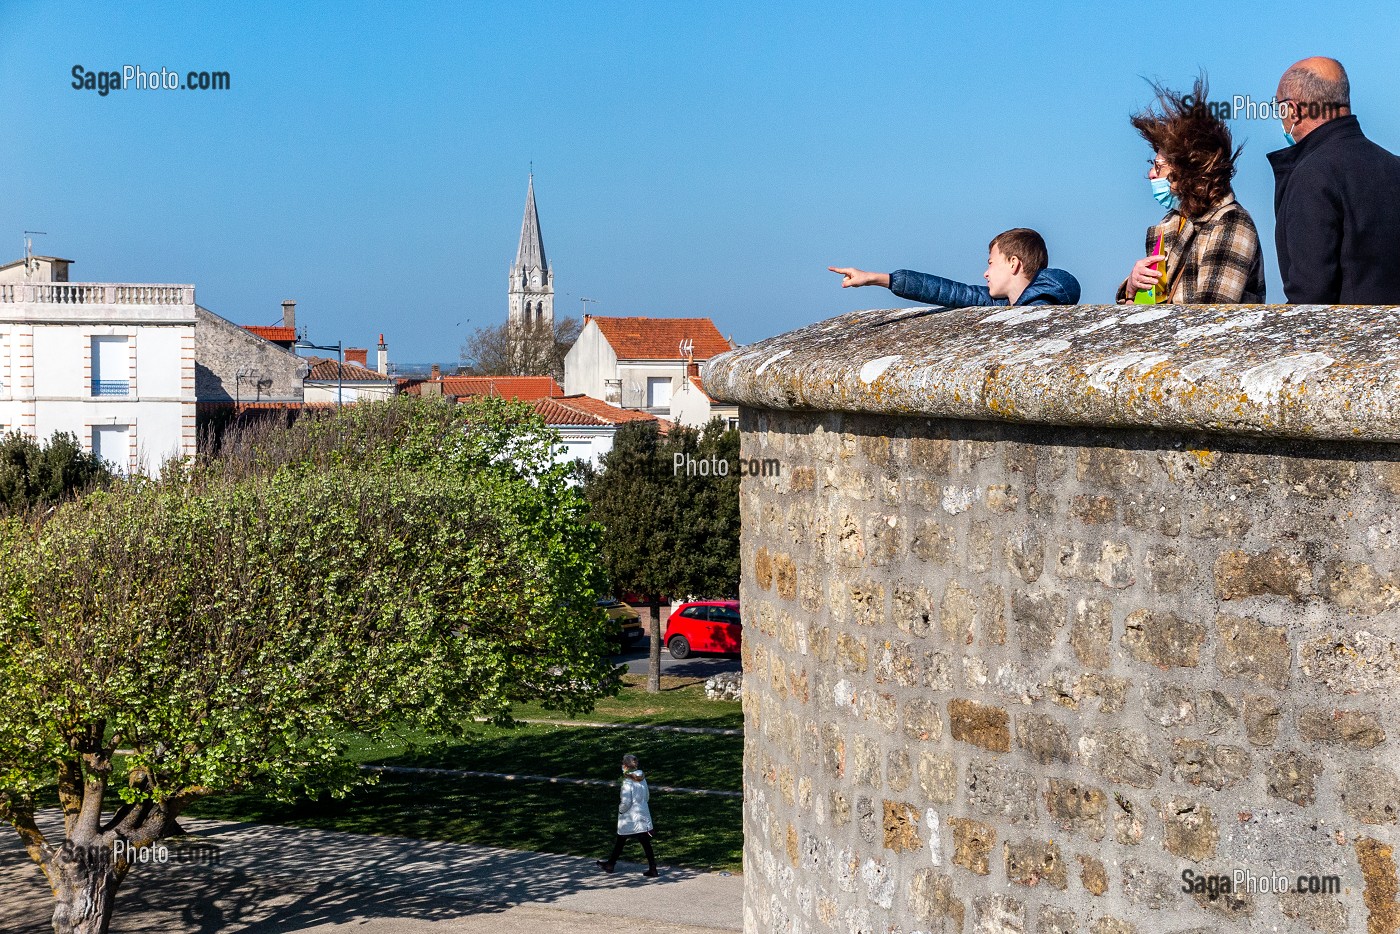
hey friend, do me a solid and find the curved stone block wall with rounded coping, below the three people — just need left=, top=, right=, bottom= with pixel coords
left=706, top=308, right=1400, bottom=934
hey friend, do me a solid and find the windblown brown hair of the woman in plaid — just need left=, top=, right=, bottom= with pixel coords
left=1131, top=77, right=1243, bottom=217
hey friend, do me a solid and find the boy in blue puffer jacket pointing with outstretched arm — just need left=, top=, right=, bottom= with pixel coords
left=827, top=227, right=1079, bottom=308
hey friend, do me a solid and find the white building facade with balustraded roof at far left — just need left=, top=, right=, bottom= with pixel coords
left=0, top=275, right=196, bottom=473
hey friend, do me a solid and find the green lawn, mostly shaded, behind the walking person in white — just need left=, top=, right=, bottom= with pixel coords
left=182, top=676, right=743, bottom=871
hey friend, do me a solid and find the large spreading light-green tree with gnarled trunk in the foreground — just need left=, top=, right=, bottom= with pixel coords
left=0, top=398, right=617, bottom=934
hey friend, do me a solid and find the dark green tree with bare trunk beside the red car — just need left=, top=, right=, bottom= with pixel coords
left=584, top=419, right=739, bottom=692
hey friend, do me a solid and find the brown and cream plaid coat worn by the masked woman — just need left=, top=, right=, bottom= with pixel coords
left=1119, top=195, right=1264, bottom=305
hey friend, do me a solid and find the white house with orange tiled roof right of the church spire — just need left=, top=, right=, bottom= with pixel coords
left=564, top=315, right=739, bottom=426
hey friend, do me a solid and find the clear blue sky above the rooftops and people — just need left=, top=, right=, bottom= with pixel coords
left=0, top=0, right=1400, bottom=363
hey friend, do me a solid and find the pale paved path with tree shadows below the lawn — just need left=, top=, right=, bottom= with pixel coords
left=0, top=815, right=743, bottom=934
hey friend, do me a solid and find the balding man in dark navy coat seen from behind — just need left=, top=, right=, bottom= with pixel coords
left=1268, top=57, right=1400, bottom=305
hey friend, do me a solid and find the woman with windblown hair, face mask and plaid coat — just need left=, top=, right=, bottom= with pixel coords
left=1117, top=78, right=1264, bottom=305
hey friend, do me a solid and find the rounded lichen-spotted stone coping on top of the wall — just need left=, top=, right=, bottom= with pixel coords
left=704, top=305, right=1400, bottom=441
